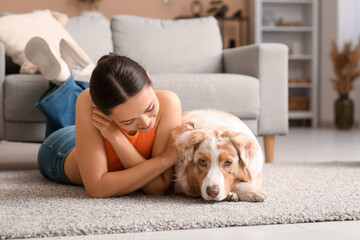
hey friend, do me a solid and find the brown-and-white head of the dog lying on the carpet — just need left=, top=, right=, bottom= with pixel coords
left=175, top=129, right=258, bottom=201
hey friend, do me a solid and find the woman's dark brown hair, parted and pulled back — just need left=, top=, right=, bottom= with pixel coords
left=90, top=53, right=152, bottom=115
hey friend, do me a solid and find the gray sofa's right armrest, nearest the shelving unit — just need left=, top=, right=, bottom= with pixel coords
left=223, top=43, right=289, bottom=135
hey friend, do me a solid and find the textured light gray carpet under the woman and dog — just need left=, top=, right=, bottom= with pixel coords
left=0, top=162, right=360, bottom=238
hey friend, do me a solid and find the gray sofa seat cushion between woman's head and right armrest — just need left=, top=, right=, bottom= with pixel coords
left=150, top=73, right=260, bottom=119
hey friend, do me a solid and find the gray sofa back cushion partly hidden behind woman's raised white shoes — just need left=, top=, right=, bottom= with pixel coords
left=65, top=14, right=114, bottom=64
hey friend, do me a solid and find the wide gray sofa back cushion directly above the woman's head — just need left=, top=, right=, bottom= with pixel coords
left=111, top=15, right=222, bottom=74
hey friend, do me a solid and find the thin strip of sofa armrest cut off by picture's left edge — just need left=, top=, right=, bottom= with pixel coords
left=0, top=42, right=5, bottom=140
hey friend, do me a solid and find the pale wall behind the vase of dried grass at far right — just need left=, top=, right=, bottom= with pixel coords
left=319, top=0, right=360, bottom=127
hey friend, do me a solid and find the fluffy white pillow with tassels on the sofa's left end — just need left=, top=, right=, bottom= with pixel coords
left=0, top=10, right=90, bottom=74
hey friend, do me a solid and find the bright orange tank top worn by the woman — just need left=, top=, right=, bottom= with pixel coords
left=74, top=128, right=155, bottom=172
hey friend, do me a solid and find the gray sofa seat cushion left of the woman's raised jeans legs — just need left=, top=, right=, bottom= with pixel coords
left=4, top=74, right=49, bottom=122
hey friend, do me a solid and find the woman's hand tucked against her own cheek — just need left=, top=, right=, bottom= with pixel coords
left=91, top=104, right=122, bottom=142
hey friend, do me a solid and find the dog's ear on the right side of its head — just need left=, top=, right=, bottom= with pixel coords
left=223, top=132, right=258, bottom=168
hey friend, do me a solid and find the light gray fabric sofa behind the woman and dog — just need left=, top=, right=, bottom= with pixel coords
left=0, top=15, right=288, bottom=167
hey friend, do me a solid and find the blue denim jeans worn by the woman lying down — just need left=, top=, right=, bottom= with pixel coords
left=35, top=76, right=89, bottom=184
